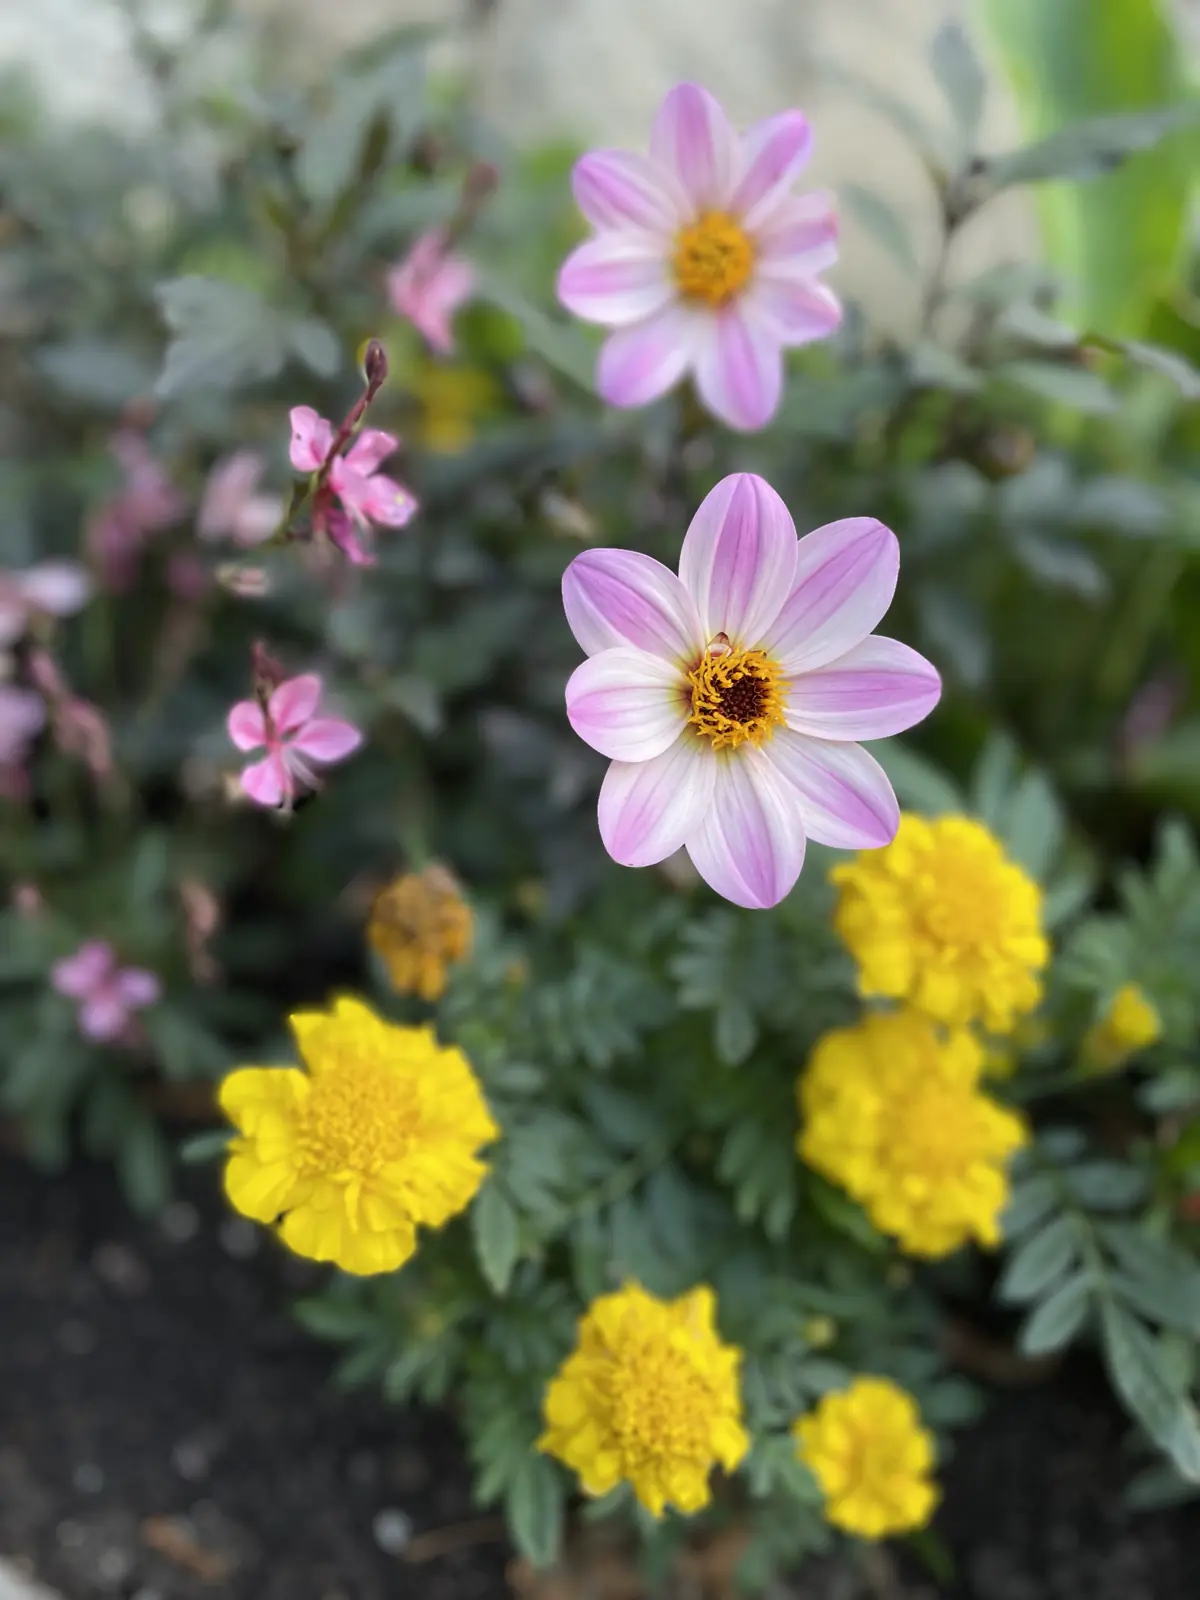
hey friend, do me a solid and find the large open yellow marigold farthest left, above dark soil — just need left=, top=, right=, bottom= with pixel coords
left=221, top=998, right=499, bottom=1274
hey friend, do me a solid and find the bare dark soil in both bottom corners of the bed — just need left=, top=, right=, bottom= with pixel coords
left=0, top=1155, right=1200, bottom=1600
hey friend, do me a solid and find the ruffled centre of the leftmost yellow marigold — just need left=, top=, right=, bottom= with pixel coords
left=296, top=1061, right=419, bottom=1174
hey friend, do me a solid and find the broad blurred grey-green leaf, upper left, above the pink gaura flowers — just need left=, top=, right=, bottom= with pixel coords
left=155, top=277, right=291, bottom=400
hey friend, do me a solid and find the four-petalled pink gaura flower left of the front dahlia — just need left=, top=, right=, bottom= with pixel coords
left=226, top=672, right=363, bottom=806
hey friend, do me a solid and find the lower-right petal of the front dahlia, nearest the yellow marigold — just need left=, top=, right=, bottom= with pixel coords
left=765, top=728, right=899, bottom=850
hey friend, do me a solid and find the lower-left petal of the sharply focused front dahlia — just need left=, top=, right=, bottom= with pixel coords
left=597, top=738, right=717, bottom=867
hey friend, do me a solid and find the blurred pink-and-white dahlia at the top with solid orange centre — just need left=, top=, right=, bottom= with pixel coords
left=558, top=83, right=842, bottom=430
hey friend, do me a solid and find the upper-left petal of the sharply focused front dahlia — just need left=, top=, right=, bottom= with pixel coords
left=563, top=550, right=704, bottom=661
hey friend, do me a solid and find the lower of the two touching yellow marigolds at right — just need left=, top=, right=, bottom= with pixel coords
left=797, top=1011, right=1027, bottom=1256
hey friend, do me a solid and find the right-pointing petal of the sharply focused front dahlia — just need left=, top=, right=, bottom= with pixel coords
left=786, top=635, right=942, bottom=741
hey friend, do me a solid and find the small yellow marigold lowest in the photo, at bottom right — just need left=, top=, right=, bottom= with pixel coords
left=792, top=1378, right=939, bottom=1539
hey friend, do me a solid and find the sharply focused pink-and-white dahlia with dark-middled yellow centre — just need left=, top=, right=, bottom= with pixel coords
left=563, top=472, right=941, bottom=907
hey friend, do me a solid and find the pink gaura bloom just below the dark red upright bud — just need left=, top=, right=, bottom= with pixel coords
left=288, top=405, right=416, bottom=566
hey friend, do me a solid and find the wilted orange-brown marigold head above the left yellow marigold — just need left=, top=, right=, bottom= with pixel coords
left=366, top=867, right=472, bottom=1000
